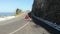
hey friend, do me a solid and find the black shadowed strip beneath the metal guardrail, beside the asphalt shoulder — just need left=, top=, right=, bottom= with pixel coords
left=33, top=18, right=60, bottom=34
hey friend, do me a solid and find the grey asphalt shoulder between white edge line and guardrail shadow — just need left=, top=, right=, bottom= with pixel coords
left=14, top=22, right=50, bottom=34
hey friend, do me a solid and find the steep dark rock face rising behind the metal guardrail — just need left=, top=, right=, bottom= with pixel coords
left=32, top=0, right=60, bottom=24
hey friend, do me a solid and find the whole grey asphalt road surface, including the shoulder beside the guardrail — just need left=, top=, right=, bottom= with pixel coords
left=0, top=14, right=49, bottom=34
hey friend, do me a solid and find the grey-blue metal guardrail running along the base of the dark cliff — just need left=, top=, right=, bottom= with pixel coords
left=31, top=13, right=60, bottom=31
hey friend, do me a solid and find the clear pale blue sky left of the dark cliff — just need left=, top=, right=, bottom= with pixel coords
left=0, top=0, right=33, bottom=13
